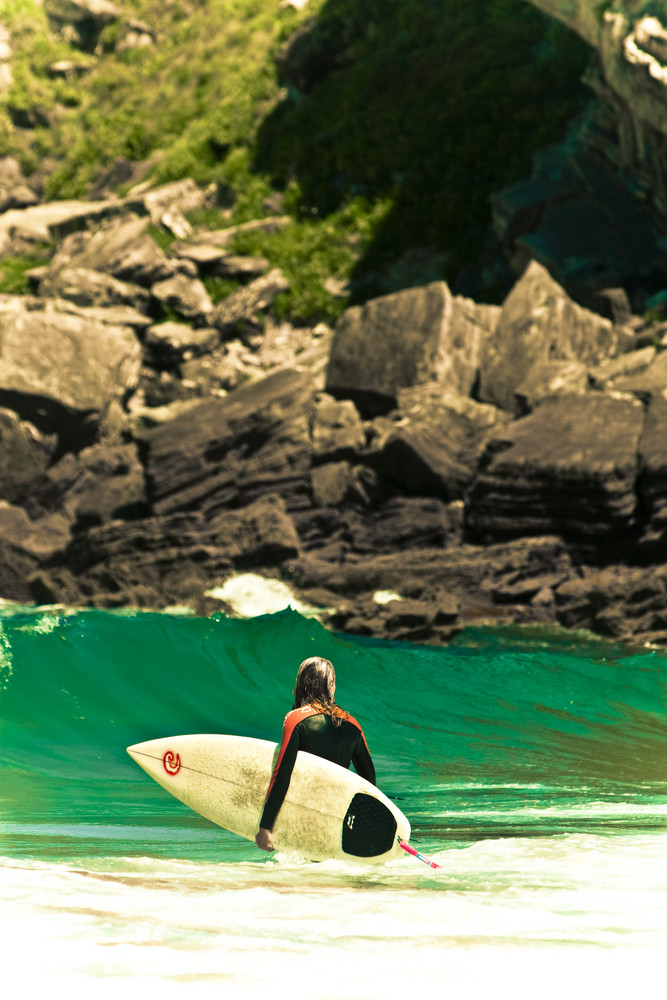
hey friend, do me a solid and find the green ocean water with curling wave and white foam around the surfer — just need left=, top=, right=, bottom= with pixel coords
left=0, top=588, right=667, bottom=1000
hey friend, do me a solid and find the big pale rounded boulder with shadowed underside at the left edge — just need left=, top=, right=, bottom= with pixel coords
left=0, top=296, right=141, bottom=435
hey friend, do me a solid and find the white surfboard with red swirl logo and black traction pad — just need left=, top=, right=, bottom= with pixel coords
left=127, top=734, right=410, bottom=864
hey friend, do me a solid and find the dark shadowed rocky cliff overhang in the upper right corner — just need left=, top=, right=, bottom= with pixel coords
left=494, top=0, right=667, bottom=311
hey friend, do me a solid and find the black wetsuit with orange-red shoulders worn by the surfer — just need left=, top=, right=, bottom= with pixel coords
left=259, top=705, right=375, bottom=830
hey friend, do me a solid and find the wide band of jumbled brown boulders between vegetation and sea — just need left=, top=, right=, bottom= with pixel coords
left=0, top=163, right=667, bottom=642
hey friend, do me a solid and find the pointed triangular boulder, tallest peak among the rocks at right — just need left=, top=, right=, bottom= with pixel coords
left=479, top=262, right=633, bottom=413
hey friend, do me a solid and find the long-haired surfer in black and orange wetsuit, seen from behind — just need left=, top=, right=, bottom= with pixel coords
left=255, top=656, right=375, bottom=851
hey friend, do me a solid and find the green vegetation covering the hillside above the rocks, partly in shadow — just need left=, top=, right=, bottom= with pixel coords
left=0, top=0, right=588, bottom=321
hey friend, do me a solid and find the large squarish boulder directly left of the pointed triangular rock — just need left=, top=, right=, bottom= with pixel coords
left=326, top=282, right=498, bottom=415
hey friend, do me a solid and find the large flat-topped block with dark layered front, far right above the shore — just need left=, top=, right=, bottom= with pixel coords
left=466, top=394, right=643, bottom=558
